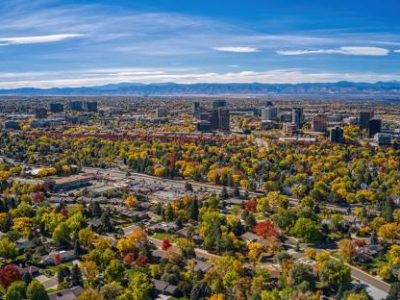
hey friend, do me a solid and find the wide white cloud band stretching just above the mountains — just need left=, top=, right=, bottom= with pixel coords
left=0, top=68, right=400, bottom=88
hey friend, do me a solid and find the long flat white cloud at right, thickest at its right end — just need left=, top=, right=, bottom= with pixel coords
left=276, top=47, right=390, bottom=56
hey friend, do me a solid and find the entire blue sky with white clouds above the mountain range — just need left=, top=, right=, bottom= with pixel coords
left=0, top=0, right=400, bottom=88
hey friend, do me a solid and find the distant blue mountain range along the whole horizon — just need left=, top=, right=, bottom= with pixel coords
left=0, top=81, right=400, bottom=98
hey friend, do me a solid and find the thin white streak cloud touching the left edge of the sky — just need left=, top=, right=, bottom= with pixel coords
left=0, top=33, right=83, bottom=46
